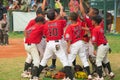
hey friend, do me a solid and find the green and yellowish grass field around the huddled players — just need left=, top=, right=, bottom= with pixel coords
left=0, top=33, right=120, bottom=80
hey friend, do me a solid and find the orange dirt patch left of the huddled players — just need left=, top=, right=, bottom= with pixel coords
left=0, top=38, right=26, bottom=58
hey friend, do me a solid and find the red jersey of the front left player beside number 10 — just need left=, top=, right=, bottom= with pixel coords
left=25, top=24, right=44, bottom=44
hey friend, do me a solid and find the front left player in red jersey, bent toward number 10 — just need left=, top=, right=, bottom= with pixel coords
left=25, top=16, right=44, bottom=80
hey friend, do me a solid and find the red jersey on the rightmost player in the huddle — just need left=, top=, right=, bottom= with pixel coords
left=92, top=26, right=107, bottom=46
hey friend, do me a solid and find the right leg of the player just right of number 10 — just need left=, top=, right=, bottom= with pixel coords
left=78, top=41, right=92, bottom=80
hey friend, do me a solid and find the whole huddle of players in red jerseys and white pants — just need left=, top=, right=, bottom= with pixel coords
left=22, top=0, right=115, bottom=80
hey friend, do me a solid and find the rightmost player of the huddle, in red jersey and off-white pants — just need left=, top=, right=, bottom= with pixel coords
left=92, top=15, right=114, bottom=80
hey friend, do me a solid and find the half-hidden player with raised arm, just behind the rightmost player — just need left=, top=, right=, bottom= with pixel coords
left=80, top=0, right=99, bottom=72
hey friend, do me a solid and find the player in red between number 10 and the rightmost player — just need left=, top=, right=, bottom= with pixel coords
left=65, top=12, right=92, bottom=80
